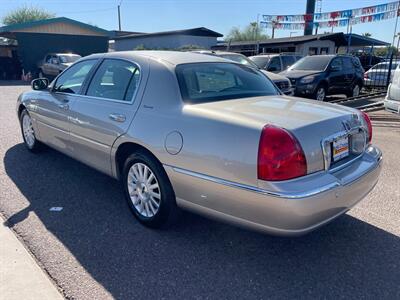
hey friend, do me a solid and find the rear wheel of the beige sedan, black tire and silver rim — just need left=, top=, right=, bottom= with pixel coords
left=122, top=151, right=179, bottom=228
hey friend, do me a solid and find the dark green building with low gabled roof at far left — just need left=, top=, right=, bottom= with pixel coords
left=0, top=17, right=109, bottom=78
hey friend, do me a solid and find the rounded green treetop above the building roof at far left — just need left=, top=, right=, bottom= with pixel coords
left=2, top=6, right=55, bottom=25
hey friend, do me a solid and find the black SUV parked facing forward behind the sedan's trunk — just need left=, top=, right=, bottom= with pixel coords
left=280, top=55, right=364, bottom=101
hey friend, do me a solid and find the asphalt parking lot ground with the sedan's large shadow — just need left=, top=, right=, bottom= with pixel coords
left=0, top=85, right=400, bottom=299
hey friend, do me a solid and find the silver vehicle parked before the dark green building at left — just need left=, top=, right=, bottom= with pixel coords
left=38, top=53, right=81, bottom=78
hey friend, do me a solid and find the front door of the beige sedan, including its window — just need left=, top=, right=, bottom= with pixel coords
left=35, top=60, right=97, bottom=154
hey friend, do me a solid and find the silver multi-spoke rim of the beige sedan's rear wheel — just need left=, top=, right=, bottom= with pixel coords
left=127, top=163, right=161, bottom=218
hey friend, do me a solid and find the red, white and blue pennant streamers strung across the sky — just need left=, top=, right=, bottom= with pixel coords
left=260, top=1, right=400, bottom=30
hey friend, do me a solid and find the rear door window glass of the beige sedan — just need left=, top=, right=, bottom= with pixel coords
left=86, top=59, right=140, bottom=102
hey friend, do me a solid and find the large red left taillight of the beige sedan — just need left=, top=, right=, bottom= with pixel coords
left=258, top=125, right=307, bottom=181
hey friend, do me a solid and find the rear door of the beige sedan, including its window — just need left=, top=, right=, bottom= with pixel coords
left=70, top=58, right=148, bottom=174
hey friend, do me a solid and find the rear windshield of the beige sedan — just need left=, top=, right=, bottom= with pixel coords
left=176, top=63, right=279, bottom=104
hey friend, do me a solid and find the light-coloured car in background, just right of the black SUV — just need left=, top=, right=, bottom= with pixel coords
left=364, top=61, right=399, bottom=88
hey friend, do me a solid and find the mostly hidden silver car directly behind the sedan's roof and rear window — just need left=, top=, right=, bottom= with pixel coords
left=192, top=50, right=293, bottom=96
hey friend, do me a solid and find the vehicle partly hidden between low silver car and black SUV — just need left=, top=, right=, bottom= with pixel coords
left=249, top=53, right=303, bottom=73
